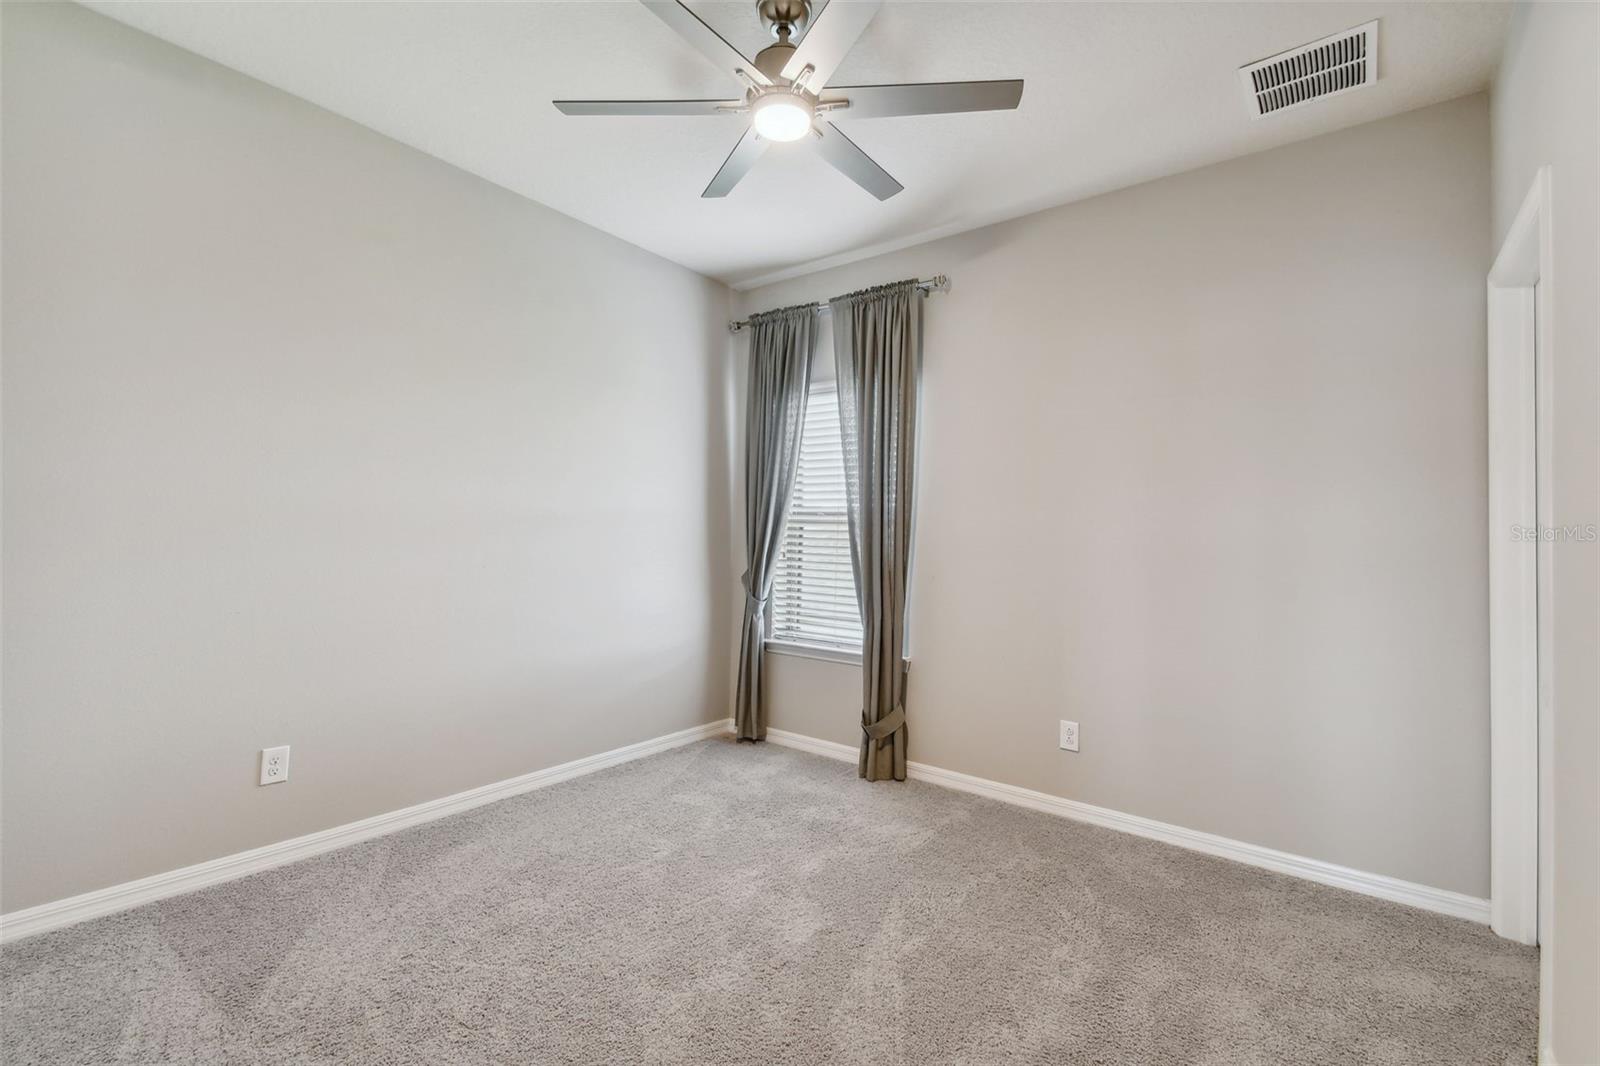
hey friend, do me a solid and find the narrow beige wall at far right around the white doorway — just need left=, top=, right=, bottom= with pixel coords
left=1491, top=3, right=1600, bottom=1066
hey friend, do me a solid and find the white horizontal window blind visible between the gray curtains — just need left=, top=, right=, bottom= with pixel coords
left=770, top=381, right=861, bottom=651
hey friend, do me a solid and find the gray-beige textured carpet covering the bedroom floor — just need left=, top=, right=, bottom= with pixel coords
left=0, top=741, right=1538, bottom=1066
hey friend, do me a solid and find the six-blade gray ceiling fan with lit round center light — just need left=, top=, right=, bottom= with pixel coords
left=555, top=0, right=1022, bottom=200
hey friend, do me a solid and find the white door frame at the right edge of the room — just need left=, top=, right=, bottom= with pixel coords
left=1488, top=166, right=1554, bottom=960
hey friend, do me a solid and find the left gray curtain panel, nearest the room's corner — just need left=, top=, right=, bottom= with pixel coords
left=734, top=304, right=818, bottom=741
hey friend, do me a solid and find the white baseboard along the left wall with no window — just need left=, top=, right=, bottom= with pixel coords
left=0, top=719, right=733, bottom=943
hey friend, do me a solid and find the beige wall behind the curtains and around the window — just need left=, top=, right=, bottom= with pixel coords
left=741, top=96, right=1490, bottom=896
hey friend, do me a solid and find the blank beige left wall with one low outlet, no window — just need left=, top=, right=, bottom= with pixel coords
left=0, top=3, right=734, bottom=911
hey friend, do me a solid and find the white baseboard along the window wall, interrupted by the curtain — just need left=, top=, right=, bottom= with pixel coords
left=766, top=728, right=1490, bottom=925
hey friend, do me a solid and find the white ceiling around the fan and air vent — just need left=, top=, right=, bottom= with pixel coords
left=88, top=0, right=1509, bottom=287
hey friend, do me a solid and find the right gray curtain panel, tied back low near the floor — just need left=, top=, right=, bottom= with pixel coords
left=832, top=280, right=922, bottom=781
